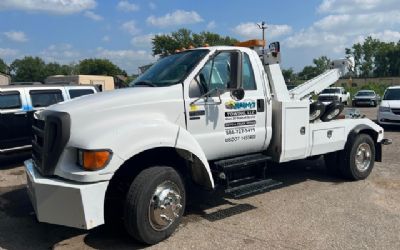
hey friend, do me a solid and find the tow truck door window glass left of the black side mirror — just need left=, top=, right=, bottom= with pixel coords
left=199, top=52, right=231, bottom=90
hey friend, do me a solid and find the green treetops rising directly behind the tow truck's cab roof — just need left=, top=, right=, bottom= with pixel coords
left=153, top=29, right=238, bottom=56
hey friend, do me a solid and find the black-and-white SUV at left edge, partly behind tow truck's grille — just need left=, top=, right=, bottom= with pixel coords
left=0, top=85, right=98, bottom=155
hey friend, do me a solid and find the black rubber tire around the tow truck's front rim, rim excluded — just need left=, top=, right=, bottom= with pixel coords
left=124, top=166, right=186, bottom=245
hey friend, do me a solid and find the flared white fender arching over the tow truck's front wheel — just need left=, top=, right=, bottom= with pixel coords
left=69, top=116, right=214, bottom=188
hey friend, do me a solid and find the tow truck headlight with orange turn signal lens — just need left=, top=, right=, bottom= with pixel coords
left=78, top=149, right=112, bottom=171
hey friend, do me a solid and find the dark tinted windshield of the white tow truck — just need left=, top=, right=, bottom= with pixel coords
left=129, top=49, right=209, bottom=87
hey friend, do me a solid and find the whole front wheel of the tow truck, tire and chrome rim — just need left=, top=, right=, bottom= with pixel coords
left=124, top=167, right=186, bottom=244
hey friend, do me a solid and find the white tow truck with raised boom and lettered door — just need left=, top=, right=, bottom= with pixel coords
left=25, top=40, right=390, bottom=244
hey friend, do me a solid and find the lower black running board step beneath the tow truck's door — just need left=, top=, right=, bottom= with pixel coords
left=225, top=179, right=282, bottom=198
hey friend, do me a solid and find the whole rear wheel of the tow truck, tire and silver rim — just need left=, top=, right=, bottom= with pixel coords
left=339, top=134, right=375, bottom=180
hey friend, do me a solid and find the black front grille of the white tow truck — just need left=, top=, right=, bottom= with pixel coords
left=32, top=110, right=71, bottom=175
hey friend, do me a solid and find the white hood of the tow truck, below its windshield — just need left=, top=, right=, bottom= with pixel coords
left=43, top=84, right=186, bottom=146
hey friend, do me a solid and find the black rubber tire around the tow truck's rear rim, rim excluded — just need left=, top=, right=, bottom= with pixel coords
left=338, top=134, right=375, bottom=180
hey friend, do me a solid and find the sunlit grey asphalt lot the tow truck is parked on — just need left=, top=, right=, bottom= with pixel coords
left=0, top=108, right=400, bottom=249
